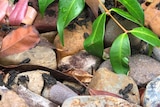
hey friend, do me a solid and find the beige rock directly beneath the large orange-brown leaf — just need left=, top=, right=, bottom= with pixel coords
left=0, top=46, right=57, bottom=69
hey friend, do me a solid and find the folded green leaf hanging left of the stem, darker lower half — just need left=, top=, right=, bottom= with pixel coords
left=84, top=13, right=106, bottom=58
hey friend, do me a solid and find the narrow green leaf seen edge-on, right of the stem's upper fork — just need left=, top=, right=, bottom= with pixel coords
left=110, top=8, right=143, bottom=26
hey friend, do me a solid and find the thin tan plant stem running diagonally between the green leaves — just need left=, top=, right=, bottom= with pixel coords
left=98, top=0, right=128, bottom=33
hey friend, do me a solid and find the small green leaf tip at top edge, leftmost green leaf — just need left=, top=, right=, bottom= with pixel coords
left=38, top=0, right=54, bottom=16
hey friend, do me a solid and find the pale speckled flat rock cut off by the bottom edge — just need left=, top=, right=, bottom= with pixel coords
left=62, top=96, right=141, bottom=107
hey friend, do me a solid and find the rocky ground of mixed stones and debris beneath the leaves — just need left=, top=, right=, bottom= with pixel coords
left=0, top=0, right=160, bottom=107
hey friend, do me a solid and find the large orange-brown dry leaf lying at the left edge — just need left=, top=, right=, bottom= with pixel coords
left=0, top=26, right=40, bottom=57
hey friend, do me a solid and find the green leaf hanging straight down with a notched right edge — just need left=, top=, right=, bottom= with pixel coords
left=110, top=33, right=131, bottom=75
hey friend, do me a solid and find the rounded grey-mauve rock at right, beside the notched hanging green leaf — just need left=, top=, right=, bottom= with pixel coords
left=129, top=54, right=160, bottom=86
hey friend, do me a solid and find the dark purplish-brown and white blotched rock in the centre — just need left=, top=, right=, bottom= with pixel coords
left=58, top=50, right=101, bottom=74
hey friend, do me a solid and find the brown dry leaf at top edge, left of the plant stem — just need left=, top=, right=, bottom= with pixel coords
left=85, top=0, right=99, bottom=17
